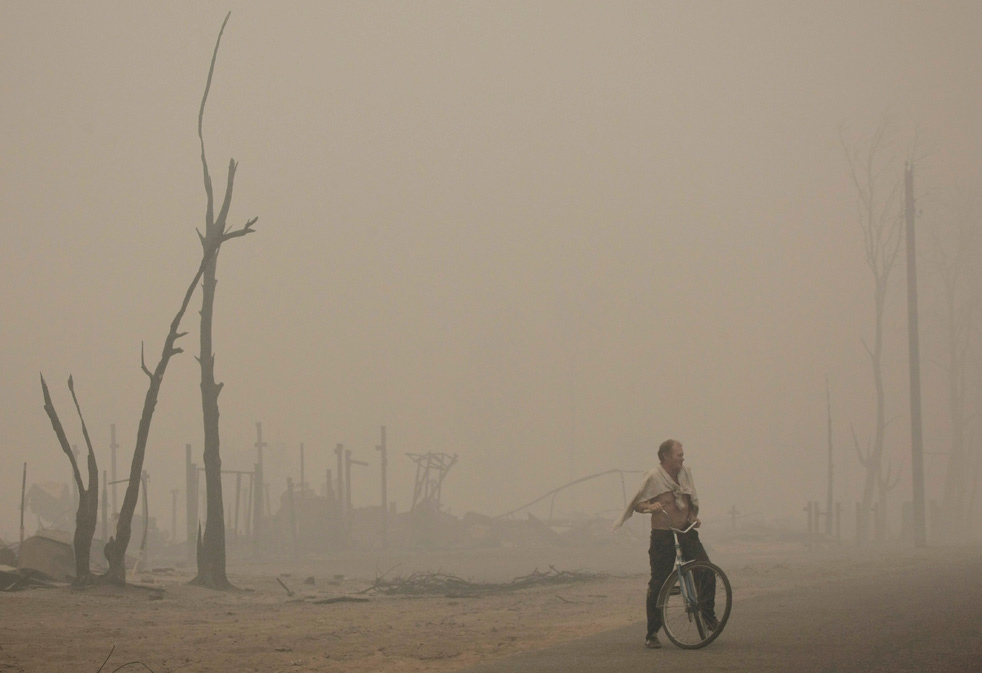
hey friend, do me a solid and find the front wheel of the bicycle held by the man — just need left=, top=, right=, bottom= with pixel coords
left=657, top=561, right=733, bottom=650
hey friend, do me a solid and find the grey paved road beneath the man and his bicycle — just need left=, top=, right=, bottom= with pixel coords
left=467, top=550, right=982, bottom=673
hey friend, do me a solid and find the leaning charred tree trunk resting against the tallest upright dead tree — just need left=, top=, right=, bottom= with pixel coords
left=105, top=221, right=254, bottom=584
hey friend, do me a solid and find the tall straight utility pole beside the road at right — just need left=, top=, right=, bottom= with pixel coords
left=904, top=162, right=927, bottom=547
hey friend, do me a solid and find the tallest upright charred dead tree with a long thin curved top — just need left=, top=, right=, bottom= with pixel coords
left=191, top=12, right=257, bottom=589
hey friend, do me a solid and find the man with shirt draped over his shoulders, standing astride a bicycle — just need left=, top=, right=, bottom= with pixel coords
left=614, top=439, right=715, bottom=649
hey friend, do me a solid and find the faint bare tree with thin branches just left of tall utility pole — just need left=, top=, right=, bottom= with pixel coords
left=840, top=119, right=903, bottom=542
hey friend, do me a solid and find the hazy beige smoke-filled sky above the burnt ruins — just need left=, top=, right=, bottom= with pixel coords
left=0, top=0, right=982, bottom=539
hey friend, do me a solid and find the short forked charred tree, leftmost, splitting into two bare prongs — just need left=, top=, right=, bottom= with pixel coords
left=41, top=375, right=99, bottom=587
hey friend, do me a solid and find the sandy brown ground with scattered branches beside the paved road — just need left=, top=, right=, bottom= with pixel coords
left=0, top=532, right=952, bottom=673
